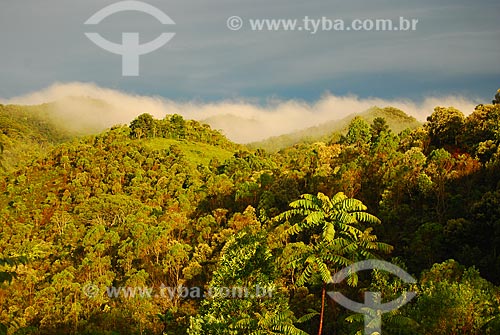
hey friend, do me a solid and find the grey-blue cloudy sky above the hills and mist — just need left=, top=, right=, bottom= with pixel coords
left=0, top=0, right=500, bottom=141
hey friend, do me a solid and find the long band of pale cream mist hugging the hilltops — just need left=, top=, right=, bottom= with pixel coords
left=0, top=83, right=480, bottom=143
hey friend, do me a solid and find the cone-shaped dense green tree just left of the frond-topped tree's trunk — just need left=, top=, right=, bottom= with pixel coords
left=188, top=222, right=306, bottom=335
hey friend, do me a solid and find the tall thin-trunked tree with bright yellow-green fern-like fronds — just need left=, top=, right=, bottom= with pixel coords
left=275, top=192, right=392, bottom=335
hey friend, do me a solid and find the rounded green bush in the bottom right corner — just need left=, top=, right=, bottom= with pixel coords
left=407, top=260, right=500, bottom=335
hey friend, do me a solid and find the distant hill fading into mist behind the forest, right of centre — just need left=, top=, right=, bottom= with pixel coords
left=248, top=107, right=422, bottom=152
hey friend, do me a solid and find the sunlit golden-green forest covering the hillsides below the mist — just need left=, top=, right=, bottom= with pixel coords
left=0, top=92, right=500, bottom=335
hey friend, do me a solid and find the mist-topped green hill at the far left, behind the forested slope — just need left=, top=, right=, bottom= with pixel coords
left=0, top=96, right=152, bottom=171
